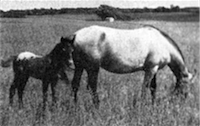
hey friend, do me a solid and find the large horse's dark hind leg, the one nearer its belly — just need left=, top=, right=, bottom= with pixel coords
left=86, top=66, right=99, bottom=108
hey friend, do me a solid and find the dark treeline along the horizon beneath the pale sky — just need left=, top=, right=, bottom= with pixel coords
left=0, top=5, right=199, bottom=20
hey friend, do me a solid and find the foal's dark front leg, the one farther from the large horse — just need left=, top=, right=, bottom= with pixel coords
left=42, top=80, right=49, bottom=110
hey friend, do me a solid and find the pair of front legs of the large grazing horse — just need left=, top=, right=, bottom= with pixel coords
left=141, top=66, right=158, bottom=100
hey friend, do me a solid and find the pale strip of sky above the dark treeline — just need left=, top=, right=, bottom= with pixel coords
left=0, top=0, right=200, bottom=11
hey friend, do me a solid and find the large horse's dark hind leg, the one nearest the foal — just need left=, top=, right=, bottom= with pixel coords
left=72, top=66, right=83, bottom=102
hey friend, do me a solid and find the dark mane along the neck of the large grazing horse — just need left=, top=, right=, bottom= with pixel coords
left=144, top=25, right=185, bottom=61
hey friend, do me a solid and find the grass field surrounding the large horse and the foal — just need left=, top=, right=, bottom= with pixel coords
left=0, top=15, right=200, bottom=126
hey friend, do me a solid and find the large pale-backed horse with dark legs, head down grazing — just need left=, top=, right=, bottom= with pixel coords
left=61, top=26, right=192, bottom=107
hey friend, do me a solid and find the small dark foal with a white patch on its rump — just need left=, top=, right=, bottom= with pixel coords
left=1, top=43, right=70, bottom=109
